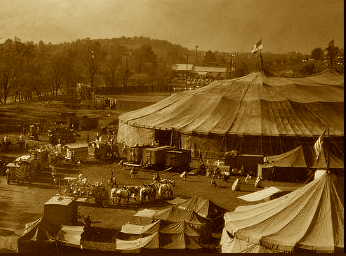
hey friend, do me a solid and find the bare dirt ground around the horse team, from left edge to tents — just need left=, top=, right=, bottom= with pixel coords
left=0, top=142, right=301, bottom=251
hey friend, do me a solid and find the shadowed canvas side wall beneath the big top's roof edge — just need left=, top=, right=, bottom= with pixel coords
left=118, top=122, right=344, bottom=166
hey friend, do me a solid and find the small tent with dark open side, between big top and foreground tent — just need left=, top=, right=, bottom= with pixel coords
left=257, top=146, right=308, bottom=181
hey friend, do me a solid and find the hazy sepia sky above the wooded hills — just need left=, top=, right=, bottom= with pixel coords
left=0, top=0, right=344, bottom=54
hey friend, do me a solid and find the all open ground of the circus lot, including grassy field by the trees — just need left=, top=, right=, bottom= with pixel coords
left=0, top=96, right=302, bottom=252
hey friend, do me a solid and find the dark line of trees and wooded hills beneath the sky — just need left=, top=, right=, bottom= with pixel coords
left=0, top=37, right=344, bottom=104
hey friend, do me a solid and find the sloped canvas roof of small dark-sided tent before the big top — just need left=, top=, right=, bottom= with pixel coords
left=267, top=146, right=306, bottom=167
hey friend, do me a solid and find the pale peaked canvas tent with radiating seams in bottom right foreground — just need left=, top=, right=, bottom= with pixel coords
left=220, top=174, right=344, bottom=252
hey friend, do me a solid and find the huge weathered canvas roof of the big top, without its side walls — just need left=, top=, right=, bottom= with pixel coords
left=119, top=70, right=344, bottom=137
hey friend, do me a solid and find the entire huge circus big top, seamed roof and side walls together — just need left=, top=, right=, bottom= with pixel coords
left=117, top=70, right=344, bottom=162
